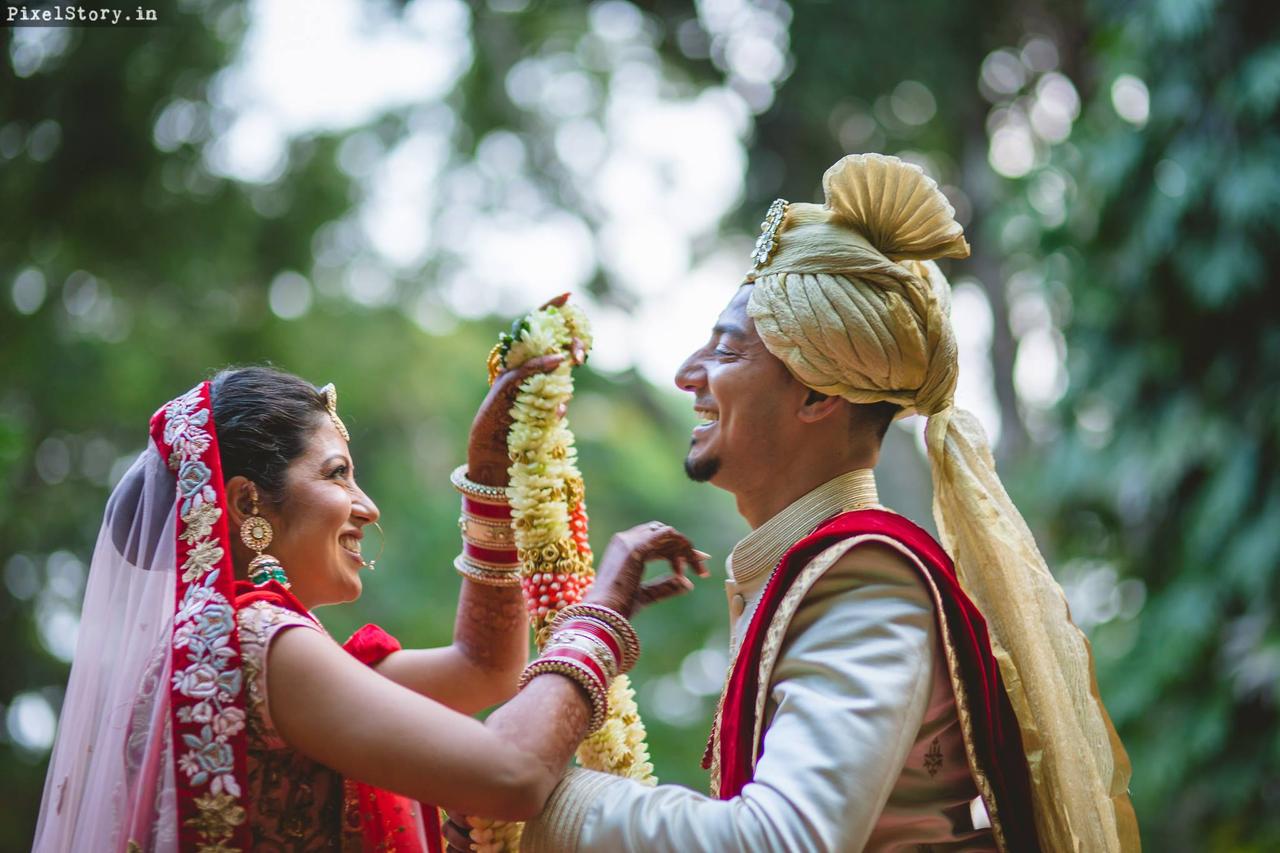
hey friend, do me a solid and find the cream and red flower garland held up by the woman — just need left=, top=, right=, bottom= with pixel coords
left=471, top=298, right=658, bottom=853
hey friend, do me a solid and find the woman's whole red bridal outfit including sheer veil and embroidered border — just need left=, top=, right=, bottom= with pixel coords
left=33, top=382, right=440, bottom=853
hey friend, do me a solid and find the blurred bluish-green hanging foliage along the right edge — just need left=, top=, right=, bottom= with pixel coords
left=1018, top=1, right=1280, bottom=850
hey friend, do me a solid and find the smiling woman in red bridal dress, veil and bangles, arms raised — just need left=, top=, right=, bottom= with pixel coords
left=35, top=356, right=705, bottom=853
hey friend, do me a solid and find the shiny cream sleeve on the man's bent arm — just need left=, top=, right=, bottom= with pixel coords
left=521, top=547, right=936, bottom=853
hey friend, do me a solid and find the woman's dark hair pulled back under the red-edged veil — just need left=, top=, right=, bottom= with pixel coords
left=211, top=366, right=326, bottom=503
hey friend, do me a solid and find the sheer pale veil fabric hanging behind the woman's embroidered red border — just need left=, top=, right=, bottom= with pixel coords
left=33, top=442, right=178, bottom=853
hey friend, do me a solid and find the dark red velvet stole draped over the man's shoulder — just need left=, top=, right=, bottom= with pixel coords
left=716, top=510, right=1039, bottom=853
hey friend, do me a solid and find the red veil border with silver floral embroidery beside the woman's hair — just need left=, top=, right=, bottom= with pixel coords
left=151, top=382, right=248, bottom=853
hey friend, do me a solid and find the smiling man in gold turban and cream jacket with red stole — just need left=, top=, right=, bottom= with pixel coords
left=448, top=155, right=1137, bottom=853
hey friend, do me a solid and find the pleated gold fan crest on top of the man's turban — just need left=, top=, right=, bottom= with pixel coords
left=822, top=154, right=969, bottom=261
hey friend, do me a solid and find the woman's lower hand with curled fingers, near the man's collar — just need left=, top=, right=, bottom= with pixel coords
left=585, top=521, right=710, bottom=616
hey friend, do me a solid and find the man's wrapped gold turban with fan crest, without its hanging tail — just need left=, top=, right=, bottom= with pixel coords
left=748, top=154, right=969, bottom=415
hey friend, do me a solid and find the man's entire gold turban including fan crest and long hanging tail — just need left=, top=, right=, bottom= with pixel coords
left=748, top=154, right=1138, bottom=853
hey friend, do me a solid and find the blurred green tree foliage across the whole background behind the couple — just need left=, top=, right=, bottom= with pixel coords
left=0, top=0, right=1280, bottom=850
